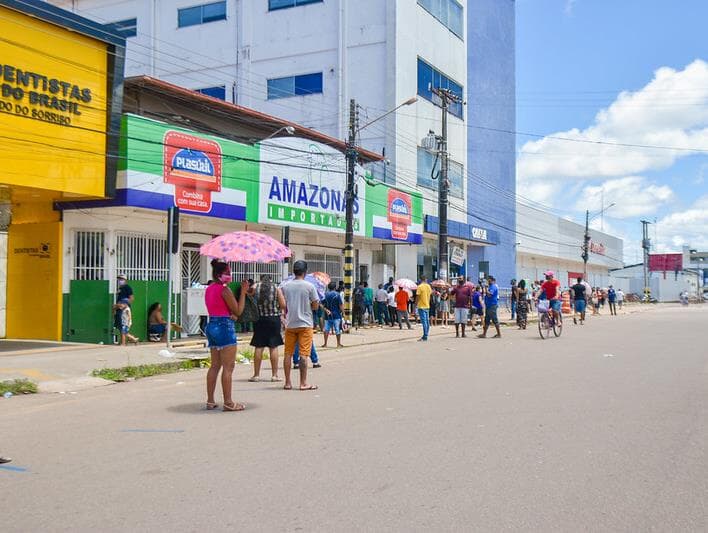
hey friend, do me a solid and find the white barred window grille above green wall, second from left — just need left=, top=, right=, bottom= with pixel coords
left=116, top=233, right=167, bottom=281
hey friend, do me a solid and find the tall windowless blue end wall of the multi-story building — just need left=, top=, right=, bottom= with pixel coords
left=467, top=0, right=517, bottom=286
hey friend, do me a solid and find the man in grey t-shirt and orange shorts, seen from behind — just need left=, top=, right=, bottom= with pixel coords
left=282, top=259, right=320, bottom=390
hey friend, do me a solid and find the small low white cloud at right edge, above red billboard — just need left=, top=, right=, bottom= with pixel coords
left=651, top=195, right=708, bottom=252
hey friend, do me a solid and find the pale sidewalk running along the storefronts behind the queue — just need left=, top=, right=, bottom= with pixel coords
left=0, top=304, right=678, bottom=392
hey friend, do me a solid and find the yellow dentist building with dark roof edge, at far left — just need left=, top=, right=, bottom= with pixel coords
left=0, top=0, right=125, bottom=340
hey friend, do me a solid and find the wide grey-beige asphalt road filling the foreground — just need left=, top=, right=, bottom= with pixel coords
left=0, top=306, right=708, bottom=532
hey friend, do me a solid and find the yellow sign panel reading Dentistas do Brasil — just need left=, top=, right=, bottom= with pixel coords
left=0, top=6, right=109, bottom=199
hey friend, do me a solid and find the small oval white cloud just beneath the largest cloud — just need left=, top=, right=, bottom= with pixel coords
left=575, top=176, right=674, bottom=218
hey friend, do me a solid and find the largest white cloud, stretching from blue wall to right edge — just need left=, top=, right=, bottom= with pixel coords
left=517, top=60, right=708, bottom=180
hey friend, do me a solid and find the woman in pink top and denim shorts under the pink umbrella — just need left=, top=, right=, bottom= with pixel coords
left=204, top=259, right=248, bottom=411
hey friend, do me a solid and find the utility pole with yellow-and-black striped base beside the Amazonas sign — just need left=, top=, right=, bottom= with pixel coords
left=344, top=98, right=359, bottom=324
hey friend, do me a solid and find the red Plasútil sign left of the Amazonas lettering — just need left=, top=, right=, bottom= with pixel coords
left=163, top=131, right=221, bottom=213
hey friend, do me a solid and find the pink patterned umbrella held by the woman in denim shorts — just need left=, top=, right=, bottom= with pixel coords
left=199, top=231, right=292, bottom=263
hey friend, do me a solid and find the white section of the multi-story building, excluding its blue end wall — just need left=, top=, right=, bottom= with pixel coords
left=51, top=0, right=513, bottom=277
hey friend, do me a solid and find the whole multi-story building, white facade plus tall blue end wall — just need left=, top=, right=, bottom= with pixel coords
left=48, top=0, right=515, bottom=281
